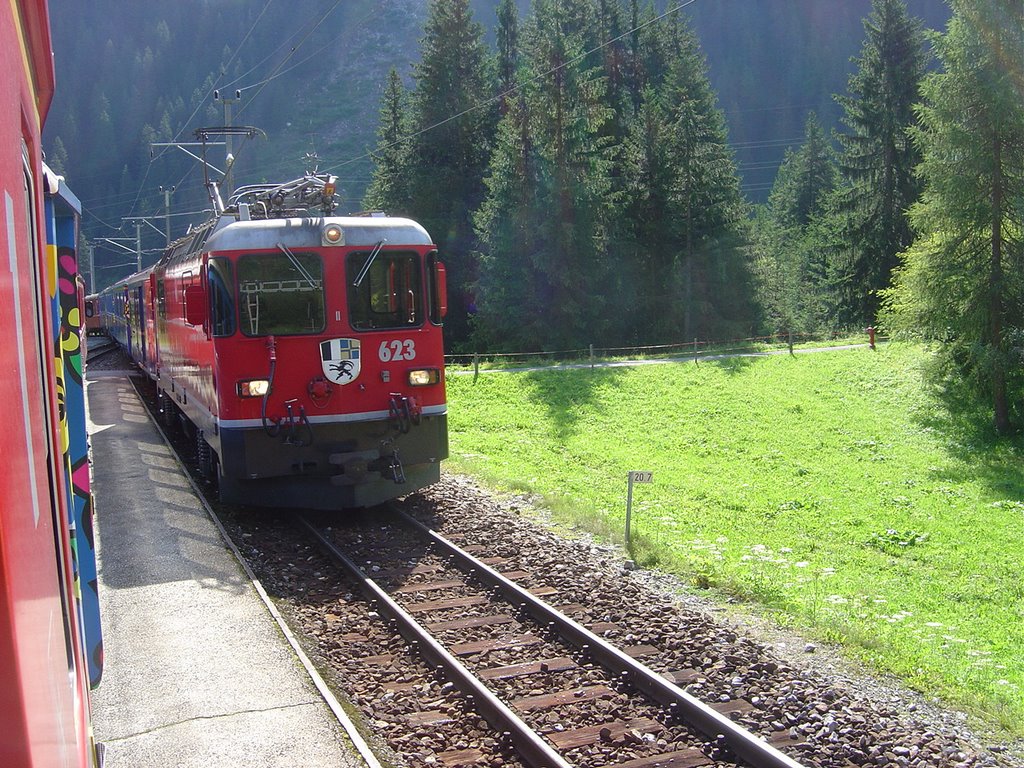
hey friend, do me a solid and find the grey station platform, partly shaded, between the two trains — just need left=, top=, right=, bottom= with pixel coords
left=86, top=372, right=376, bottom=768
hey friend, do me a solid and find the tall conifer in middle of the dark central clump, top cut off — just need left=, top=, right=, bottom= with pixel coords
left=477, top=0, right=611, bottom=349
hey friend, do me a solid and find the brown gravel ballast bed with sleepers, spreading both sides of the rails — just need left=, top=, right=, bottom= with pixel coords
left=125, top=379, right=1019, bottom=768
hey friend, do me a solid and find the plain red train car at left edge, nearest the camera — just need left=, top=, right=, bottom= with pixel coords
left=0, top=0, right=98, bottom=768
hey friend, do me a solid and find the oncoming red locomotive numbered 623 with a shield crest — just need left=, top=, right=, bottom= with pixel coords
left=100, top=174, right=447, bottom=510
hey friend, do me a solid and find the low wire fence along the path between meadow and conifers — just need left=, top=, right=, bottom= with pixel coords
left=444, top=329, right=878, bottom=369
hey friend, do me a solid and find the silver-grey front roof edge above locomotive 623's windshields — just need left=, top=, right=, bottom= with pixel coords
left=204, top=215, right=433, bottom=251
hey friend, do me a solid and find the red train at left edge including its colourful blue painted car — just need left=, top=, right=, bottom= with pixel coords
left=0, top=0, right=102, bottom=768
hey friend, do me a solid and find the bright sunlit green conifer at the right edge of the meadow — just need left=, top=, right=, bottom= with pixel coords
left=884, top=0, right=1024, bottom=433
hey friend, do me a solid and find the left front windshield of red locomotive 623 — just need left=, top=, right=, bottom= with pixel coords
left=238, top=252, right=325, bottom=336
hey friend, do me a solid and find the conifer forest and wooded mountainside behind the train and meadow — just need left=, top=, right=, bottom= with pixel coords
left=45, top=0, right=1024, bottom=433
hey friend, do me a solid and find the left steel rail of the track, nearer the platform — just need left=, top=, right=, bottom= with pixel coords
left=299, top=515, right=572, bottom=768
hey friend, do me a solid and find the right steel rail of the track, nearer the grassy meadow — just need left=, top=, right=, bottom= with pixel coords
left=397, top=510, right=804, bottom=768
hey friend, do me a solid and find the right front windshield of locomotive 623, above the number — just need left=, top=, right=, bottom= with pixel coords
left=345, top=249, right=423, bottom=331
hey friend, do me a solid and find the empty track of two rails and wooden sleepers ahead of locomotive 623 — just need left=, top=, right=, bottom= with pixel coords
left=302, top=513, right=800, bottom=768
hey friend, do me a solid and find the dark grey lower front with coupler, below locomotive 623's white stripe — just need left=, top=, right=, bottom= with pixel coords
left=218, top=415, right=447, bottom=510
